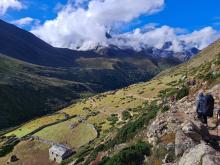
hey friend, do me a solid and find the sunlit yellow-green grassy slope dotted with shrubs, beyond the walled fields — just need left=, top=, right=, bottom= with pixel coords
left=4, top=39, right=220, bottom=138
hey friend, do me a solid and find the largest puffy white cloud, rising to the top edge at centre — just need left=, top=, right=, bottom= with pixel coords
left=32, top=0, right=164, bottom=49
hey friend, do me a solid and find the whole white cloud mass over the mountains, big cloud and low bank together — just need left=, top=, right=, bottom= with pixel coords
left=11, top=0, right=220, bottom=52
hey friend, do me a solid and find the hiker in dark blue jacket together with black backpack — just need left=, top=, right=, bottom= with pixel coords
left=196, top=92, right=214, bottom=125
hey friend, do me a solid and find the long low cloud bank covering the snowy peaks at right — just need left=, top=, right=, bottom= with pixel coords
left=110, top=26, right=220, bottom=52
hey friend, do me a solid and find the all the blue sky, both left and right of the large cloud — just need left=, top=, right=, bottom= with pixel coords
left=2, top=0, right=220, bottom=31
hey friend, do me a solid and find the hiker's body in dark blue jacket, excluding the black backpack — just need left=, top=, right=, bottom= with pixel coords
left=196, top=92, right=207, bottom=124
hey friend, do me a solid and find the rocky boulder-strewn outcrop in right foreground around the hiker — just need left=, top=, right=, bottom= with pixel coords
left=147, top=84, right=220, bottom=165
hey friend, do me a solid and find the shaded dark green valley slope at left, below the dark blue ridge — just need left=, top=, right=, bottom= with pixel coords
left=0, top=56, right=90, bottom=129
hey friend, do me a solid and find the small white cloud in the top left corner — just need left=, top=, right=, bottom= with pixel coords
left=0, top=0, right=24, bottom=16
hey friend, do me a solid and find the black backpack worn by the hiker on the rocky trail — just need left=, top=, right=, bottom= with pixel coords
left=205, top=95, right=215, bottom=117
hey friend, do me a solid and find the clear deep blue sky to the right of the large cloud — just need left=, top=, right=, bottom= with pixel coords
left=122, top=0, right=220, bottom=31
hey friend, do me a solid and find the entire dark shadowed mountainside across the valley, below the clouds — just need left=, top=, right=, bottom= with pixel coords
left=0, top=20, right=196, bottom=129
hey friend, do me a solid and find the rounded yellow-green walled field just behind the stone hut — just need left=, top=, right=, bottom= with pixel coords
left=35, top=118, right=97, bottom=148
